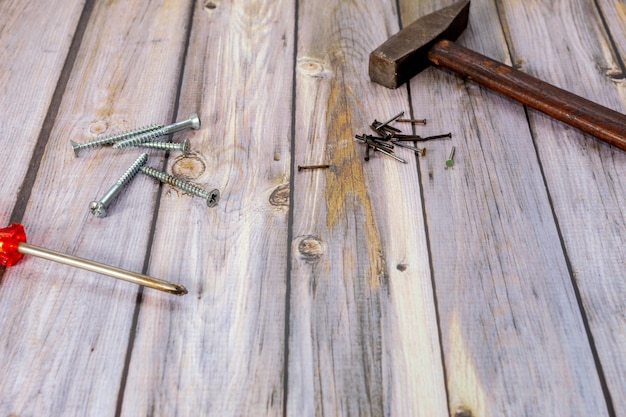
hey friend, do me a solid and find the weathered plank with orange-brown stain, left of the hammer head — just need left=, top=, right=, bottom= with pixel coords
left=287, top=1, right=446, bottom=416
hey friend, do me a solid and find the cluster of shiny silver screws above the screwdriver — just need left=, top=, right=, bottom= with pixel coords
left=70, top=113, right=220, bottom=217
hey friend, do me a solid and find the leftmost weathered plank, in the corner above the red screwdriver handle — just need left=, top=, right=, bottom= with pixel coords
left=0, top=1, right=83, bottom=225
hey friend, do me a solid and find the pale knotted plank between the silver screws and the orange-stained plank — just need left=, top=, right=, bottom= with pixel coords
left=122, top=0, right=294, bottom=416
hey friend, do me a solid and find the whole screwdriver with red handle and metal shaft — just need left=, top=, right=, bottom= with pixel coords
left=0, top=223, right=187, bottom=295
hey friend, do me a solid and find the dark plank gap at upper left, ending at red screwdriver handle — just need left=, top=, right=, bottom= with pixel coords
left=7, top=0, right=95, bottom=226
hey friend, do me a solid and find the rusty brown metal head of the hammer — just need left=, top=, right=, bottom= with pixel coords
left=369, top=0, right=470, bottom=88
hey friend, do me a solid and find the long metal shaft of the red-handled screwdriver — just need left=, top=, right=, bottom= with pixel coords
left=17, top=242, right=187, bottom=295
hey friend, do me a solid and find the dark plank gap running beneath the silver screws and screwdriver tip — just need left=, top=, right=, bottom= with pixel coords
left=115, top=1, right=196, bottom=417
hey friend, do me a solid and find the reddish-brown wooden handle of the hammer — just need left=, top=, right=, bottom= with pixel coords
left=428, top=40, right=626, bottom=150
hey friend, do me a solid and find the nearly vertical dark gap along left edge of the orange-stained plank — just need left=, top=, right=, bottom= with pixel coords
left=283, top=0, right=300, bottom=417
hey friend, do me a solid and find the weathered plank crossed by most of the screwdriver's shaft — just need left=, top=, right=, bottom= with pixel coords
left=0, top=1, right=191, bottom=415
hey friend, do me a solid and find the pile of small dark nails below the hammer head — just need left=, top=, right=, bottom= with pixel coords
left=354, top=112, right=452, bottom=164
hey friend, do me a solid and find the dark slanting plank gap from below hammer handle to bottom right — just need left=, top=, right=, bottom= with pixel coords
left=524, top=113, right=617, bottom=417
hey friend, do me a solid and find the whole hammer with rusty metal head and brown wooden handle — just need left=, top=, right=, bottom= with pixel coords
left=369, top=0, right=626, bottom=150
